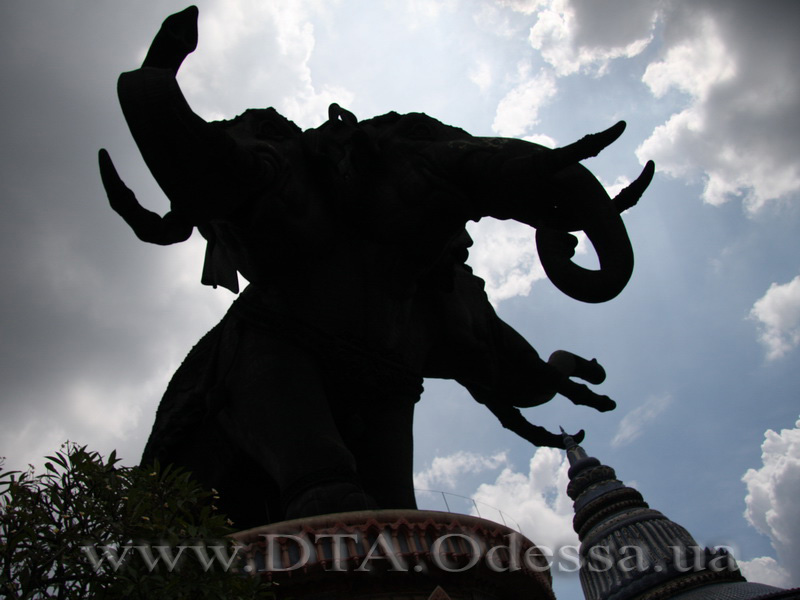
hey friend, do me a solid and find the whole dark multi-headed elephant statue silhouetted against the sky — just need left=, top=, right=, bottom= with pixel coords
left=99, top=7, right=653, bottom=527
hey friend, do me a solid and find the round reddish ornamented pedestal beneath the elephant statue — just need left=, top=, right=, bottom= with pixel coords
left=232, top=510, right=555, bottom=600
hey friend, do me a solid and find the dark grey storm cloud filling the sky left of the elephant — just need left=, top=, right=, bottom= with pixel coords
left=0, top=2, right=231, bottom=460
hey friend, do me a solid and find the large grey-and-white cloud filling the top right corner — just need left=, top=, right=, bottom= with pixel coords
left=637, top=0, right=800, bottom=213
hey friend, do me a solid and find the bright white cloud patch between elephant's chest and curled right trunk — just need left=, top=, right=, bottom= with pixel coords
left=468, top=218, right=546, bottom=306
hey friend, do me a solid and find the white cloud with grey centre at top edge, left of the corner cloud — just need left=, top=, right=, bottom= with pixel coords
left=530, top=0, right=656, bottom=76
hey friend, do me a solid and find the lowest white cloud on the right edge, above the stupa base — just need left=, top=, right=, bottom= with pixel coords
left=742, top=420, right=800, bottom=587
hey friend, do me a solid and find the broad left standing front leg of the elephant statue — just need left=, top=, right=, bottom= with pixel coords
left=220, top=331, right=374, bottom=519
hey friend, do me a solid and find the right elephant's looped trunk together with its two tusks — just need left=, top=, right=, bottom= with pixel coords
left=451, top=128, right=654, bottom=303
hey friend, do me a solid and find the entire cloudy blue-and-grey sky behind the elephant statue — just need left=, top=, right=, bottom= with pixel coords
left=0, top=0, right=800, bottom=598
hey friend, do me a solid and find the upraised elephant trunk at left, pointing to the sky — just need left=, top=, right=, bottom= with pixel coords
left=117, top=9, right=266, bottom=224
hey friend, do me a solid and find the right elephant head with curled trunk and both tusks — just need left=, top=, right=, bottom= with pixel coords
left=326, top=107, right=655, bottom=303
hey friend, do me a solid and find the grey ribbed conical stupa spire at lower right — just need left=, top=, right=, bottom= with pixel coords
left=562, top=430, right=800, bottom=600
